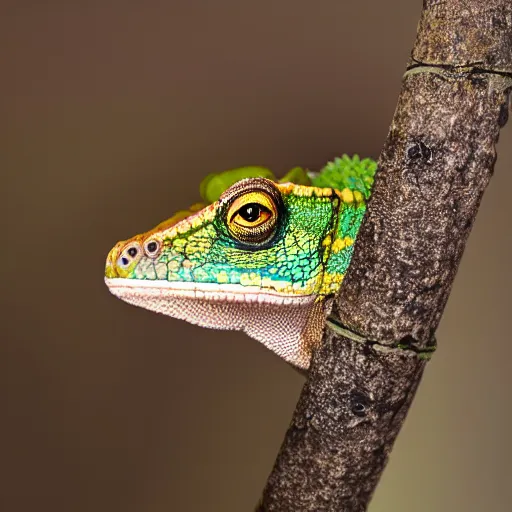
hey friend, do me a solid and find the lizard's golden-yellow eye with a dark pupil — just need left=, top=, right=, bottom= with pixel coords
left=226, top=190, right=278, bottom=244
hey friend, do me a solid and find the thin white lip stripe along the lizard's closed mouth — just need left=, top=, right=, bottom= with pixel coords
left=105, top=277, right=316, bottom=305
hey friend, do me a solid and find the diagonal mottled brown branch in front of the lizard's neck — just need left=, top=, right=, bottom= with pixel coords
left=258, top=0, right=512, bottom=512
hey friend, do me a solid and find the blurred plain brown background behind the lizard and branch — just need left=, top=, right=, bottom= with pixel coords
left=0, top=0, right=512, bottom=512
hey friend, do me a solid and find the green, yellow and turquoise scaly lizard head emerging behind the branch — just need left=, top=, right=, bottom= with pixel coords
left=105, top=155, right=377, bottom=370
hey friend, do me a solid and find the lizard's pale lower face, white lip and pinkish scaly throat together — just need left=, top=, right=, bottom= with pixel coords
left=105, top=278, right=324, bottom=369
